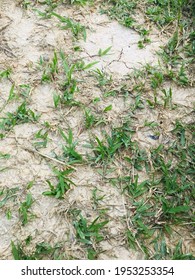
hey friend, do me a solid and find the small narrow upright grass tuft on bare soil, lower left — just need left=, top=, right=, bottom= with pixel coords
left=19, top=194, right=34, bottom=226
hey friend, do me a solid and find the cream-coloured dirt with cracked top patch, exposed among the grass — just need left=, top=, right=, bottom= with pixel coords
left=0, top=1, right=194, bottom=259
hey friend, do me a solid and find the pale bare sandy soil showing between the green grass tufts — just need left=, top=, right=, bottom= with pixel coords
left=0, top=0, right=194, bottom=259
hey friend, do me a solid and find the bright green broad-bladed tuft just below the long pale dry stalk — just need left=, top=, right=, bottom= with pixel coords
left=43, top=168, right=75, bottom=199
